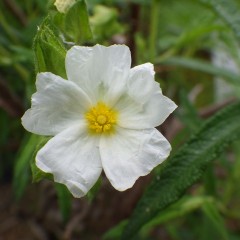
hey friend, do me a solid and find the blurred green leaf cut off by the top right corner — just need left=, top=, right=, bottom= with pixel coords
left=199, top=0, right=240, bottom=40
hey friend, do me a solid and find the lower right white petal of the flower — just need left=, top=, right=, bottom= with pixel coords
left=100, top=128, right=171, bottom=191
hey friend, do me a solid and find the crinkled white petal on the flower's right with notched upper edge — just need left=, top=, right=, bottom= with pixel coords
left=114, top=63, right=177, bottom=129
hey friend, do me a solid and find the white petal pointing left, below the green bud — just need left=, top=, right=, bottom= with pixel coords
left=22, top=73, right=91, bottom=135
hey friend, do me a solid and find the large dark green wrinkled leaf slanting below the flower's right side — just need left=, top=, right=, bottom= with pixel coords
left=122, top=102, right=240, bottom=240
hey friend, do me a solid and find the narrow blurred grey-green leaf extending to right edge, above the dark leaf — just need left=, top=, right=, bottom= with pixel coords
left=162, top=57, right=240, bottom=87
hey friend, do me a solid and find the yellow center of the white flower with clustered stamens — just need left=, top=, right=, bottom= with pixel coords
left=85, top=102, right=117, bottom=133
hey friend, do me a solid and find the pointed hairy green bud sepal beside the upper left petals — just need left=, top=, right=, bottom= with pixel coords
left=33, top=17, right=66, bottom=78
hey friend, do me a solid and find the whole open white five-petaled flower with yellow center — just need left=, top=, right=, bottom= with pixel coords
left=22, top=45, right=176, bottom=197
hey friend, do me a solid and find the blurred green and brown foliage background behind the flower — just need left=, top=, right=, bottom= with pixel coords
left=0, top=0, right=240, bottom=240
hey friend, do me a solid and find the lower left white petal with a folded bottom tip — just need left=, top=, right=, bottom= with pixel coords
left=36, top=125, right=102, bottom=197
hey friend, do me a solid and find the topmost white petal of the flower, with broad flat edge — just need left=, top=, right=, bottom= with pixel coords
left=66, top=45, right=131, bottom=102
